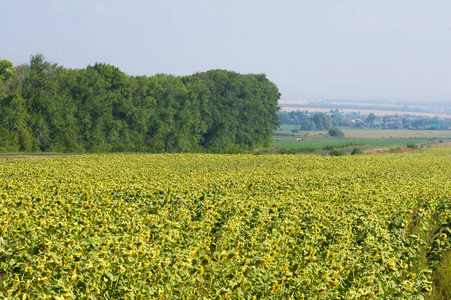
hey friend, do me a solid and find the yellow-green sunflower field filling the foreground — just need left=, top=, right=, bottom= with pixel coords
left=0, top=147, right=451, bottom=299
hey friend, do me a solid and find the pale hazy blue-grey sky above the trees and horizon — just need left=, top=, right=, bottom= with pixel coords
left=0, top=0, right=451, bottom=102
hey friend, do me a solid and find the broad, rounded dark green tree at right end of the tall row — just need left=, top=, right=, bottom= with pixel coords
left=195, top=70, right=280, bottom=149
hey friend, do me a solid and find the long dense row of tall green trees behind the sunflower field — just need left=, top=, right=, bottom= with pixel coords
left=0, top=54, right=280, bottom=152
